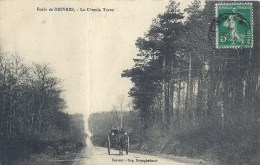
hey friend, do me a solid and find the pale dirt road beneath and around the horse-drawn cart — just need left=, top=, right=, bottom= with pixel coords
left=73, top=141, right=211, bottom=165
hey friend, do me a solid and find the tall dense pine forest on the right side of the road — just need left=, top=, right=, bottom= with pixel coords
left=89, top=0, right=260, bottom=165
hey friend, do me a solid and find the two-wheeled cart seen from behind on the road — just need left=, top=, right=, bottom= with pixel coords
left=107, top=128, right=129, bottom=155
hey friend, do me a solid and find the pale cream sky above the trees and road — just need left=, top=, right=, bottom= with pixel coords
left=0, top=0, right=194, bottom=127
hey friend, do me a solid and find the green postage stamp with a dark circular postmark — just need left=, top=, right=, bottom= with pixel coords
left=216, top=3, right=253, bottom=49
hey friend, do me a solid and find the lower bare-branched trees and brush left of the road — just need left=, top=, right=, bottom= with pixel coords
left=0, top=50, right=86, bottom=165
